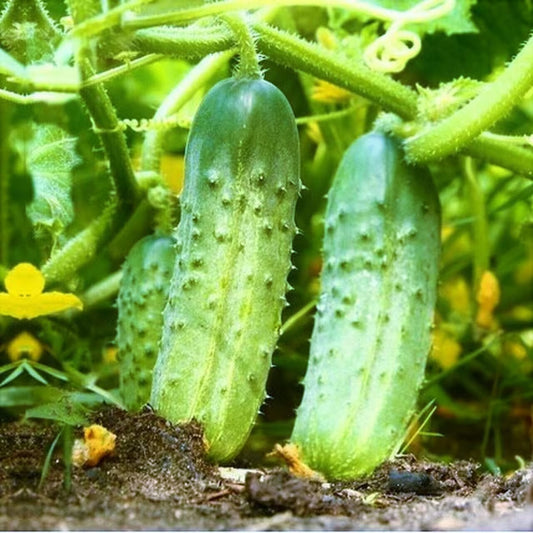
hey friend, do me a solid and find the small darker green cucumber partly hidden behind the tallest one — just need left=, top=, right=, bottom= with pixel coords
left=117, top=235, right=176, bottom=411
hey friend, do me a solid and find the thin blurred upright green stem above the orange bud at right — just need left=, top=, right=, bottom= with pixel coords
left=462, top=157, right=490, bottom=293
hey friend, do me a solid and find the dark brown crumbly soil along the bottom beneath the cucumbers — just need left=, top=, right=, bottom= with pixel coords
left=0, top=409, right=533, bottom=531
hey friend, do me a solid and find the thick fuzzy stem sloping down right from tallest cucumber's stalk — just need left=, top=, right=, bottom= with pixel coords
left=253, top=22, right=417, bottom=119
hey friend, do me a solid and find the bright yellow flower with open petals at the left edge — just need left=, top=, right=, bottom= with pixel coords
left=0, top=263, right=83, bottom=319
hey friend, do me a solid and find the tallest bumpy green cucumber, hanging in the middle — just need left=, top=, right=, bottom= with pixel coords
left=151, top=79, right=300, bottom=462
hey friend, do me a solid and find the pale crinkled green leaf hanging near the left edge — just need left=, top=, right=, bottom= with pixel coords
left=27, top=125, right=80, bottom=249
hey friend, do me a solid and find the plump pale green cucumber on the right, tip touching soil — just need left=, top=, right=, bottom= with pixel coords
left=291, top=133, right=440, bottom=480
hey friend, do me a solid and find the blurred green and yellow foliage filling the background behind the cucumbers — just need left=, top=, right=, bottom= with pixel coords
left=0, top=0, right=533, bottom=469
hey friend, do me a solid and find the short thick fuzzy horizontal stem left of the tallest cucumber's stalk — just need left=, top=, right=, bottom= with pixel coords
left=133, top=24, right=235, bottom=59
